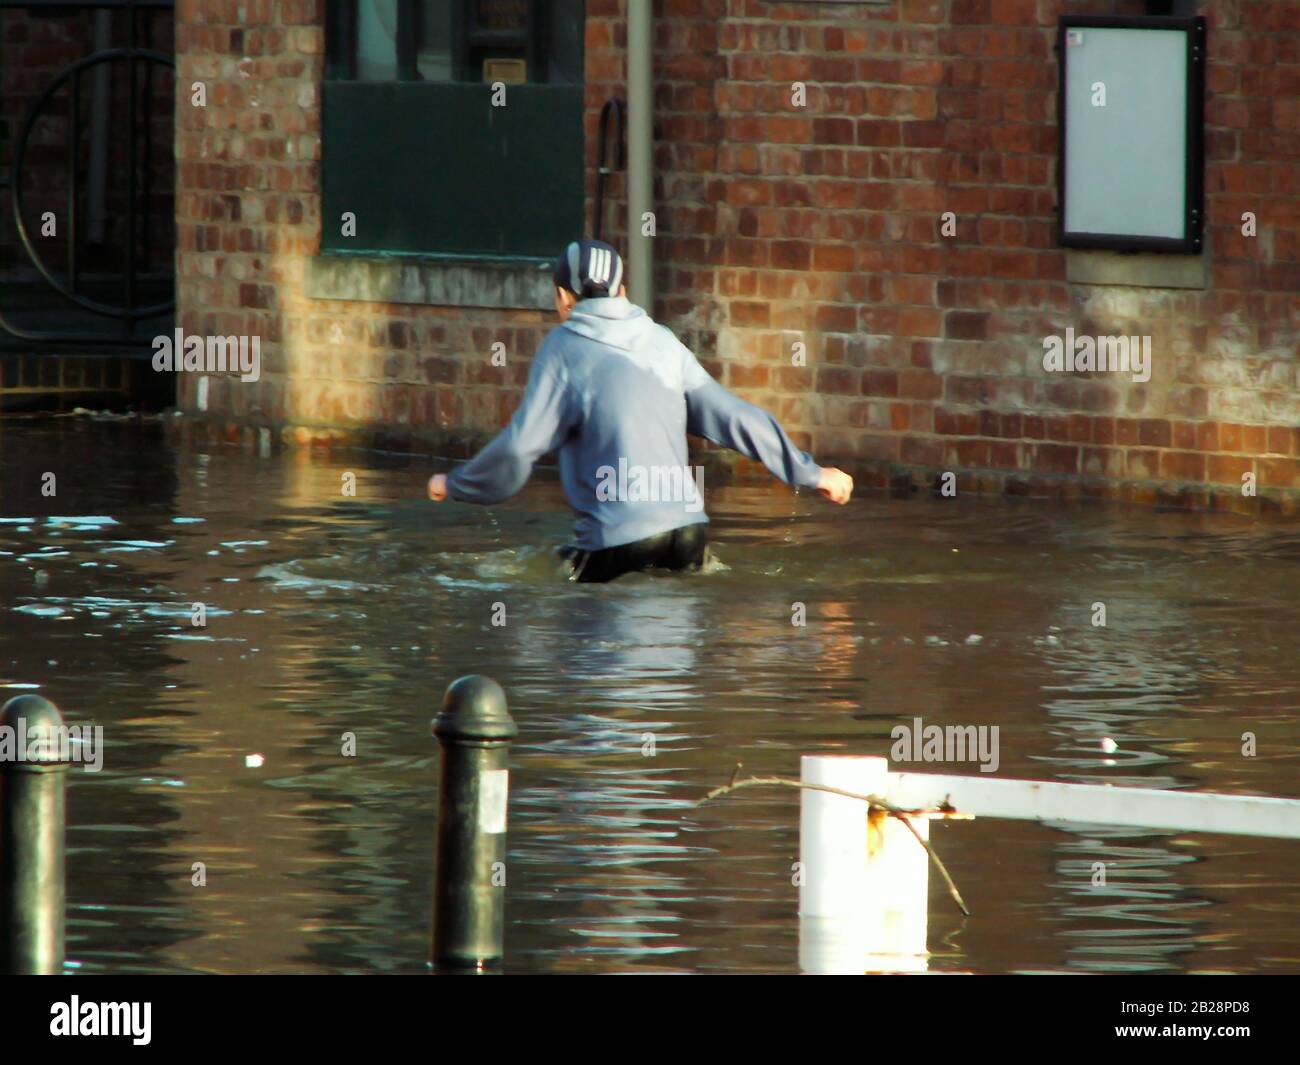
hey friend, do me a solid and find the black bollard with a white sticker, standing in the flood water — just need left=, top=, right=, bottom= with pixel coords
left=433, top=675, right=519, bottom=970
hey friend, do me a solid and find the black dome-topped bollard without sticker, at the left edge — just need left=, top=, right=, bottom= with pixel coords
left=0, top=696, right=68, bottom=975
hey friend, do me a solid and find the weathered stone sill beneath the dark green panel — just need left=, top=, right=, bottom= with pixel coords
left=304, top=254, right=555, bottom=311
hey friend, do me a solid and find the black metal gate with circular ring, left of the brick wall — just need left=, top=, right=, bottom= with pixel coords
left=0, top=0, right=176, bottom=366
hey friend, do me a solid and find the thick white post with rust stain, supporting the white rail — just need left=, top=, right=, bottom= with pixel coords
left=800, top=754, right=930, bottom=973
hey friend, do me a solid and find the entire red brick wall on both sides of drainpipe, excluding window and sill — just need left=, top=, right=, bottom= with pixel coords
left=177, top=0, right=1300, bottom=508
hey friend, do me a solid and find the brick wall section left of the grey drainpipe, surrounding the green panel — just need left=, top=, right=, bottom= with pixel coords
left=177, top=0, right=624, bottom=453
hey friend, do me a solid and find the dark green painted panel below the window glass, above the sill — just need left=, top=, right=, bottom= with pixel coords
left=321, top=82, right=584, bottom=257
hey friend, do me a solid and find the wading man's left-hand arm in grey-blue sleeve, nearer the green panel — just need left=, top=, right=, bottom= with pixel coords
left=429, top=351, right=573, bottom=503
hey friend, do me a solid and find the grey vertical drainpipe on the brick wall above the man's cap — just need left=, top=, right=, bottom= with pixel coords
left=628, top=0, right=654, bottom=316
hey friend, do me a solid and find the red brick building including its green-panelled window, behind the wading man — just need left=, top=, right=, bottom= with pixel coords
left=176, top=0, right=1300, bottom=512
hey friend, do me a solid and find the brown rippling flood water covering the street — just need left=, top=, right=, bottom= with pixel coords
left=0, top=421, right=1300, bottom=973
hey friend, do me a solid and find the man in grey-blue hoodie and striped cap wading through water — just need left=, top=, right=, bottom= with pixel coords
left=429, top=241, right=853, bottom=581
